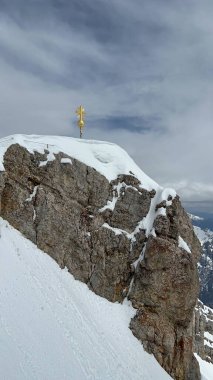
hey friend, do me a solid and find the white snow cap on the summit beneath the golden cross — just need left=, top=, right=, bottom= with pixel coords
left=0, top=135, right=161, bottom=190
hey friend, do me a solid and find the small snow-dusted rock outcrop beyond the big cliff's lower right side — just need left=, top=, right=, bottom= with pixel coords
left=195, top=301, right=213, bottom=364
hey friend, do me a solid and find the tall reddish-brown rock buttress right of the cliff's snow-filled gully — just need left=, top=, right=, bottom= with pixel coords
left=130, top=198, right=200, bottom=379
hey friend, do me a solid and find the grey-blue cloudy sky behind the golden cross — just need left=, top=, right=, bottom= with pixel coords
left=0, top=0, right=213, bottom=200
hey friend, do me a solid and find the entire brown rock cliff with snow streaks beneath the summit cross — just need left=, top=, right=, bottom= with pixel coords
left=0, top=144, right=200, bottom=380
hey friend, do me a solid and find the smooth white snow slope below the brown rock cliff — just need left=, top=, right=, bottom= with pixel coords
left=0, top=219, right=171, bottom=380
